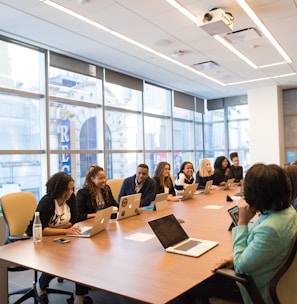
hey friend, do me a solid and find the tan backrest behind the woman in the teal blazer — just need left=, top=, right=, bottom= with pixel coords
left=269, top=233, right=297, bottom=304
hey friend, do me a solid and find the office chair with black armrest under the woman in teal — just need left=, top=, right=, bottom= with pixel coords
left=210, top=233, right=297, bottom=304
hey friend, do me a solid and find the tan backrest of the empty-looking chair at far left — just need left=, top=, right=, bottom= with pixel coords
left=1, top=192, right=37, bottom=236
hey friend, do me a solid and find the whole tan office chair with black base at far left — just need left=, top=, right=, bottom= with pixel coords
left=1, top=192, right=74, bottom=304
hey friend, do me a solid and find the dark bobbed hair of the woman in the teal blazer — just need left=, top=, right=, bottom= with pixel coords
left=244, top=163, right=291, bottom=213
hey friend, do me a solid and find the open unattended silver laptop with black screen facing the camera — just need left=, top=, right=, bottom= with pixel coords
left=148, top=214, right=219, bottom=257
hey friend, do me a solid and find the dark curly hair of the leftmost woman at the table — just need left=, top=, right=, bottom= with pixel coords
left=46, top=172, right=74, bottom=199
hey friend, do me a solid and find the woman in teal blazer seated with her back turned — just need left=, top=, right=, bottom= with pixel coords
left=180, top=164, right=297, bottom=303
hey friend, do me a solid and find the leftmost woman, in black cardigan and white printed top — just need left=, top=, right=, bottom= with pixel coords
left=27, top=172, right=92, bottom=304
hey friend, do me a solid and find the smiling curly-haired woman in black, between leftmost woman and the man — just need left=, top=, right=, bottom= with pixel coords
left=76, top=165, right=118, bottom=221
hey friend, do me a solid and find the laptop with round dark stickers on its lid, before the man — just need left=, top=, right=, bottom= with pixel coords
left=117, top=193, right=141, bottom=221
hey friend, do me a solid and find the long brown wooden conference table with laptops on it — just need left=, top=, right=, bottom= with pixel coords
left=0, top=186, right=239, bottom=303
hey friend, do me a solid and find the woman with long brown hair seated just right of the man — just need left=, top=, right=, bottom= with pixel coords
left=153, top=162, right=179, bottom=202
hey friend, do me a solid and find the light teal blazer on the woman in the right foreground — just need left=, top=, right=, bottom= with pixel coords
left=232, top=206, right=297, bottom=304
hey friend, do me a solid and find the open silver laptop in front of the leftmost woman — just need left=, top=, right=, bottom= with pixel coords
left=66, top=207, right=113, bottom=238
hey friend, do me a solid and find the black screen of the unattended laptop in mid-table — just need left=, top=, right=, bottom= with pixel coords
left=148, top=214, right=189, bottom=249
